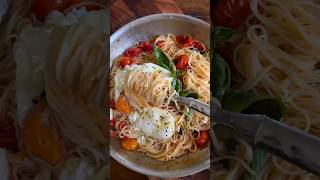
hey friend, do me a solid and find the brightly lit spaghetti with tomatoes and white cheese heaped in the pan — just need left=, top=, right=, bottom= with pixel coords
left=110, top=34, right=210, bottom=161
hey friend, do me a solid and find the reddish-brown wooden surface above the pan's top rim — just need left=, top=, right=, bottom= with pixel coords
left=110, top=0, right=210, bottom=33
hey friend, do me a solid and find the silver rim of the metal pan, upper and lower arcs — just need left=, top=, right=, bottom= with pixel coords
left=110, top=13, right=210, bottom=178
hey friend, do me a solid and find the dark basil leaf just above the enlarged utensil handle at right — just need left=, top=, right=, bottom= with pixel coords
left=241, top=98, right=286, bottom=120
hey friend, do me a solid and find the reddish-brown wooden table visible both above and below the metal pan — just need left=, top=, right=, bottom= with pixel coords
left=109, top=0, right=210, bottom=180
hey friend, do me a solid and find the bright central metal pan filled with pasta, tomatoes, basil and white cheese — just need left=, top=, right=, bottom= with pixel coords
left=110, top=14, right=210, bottom=177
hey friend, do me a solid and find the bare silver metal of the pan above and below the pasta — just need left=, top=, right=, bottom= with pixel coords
left=110, top=14, right=210, bottom=177
